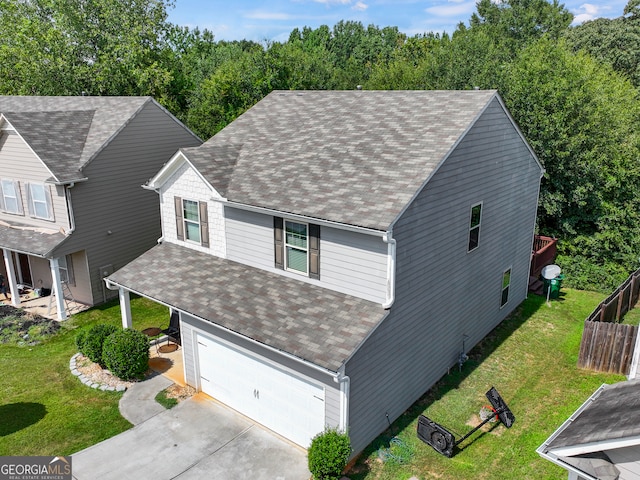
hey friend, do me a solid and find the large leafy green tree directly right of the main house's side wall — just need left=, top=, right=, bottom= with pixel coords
left=501, top=38, right=640, bottom=288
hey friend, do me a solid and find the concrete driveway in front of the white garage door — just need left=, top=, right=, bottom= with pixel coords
left=72, top=394, right=311, bottom=480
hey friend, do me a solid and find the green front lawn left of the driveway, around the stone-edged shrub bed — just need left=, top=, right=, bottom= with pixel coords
left=0, top=298, right=169, bottom=456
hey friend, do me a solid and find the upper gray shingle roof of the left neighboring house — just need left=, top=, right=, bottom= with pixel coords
left=0, top=96, right=152, bottom=182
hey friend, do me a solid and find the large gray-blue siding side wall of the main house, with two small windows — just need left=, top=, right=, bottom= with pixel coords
left=346, top=96, right=541, bottom=452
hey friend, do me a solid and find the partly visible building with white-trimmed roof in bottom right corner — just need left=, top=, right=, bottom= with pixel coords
left=537, top=380, right=640, bottom=480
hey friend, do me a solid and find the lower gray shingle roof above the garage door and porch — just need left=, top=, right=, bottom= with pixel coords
left=109, top=243, right=385, bottom=371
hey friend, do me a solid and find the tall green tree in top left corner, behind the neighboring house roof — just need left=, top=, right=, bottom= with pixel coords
left=0, top=0, right=171, bottom=97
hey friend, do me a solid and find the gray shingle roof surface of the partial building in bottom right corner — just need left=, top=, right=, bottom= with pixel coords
left=547, top=380, right=640, bottom=451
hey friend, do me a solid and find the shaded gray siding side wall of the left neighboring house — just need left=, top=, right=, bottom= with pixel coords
left=56, top=102, right=200, bottom=303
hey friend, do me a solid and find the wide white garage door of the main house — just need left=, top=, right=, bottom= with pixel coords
left=197, top=335, right=325, bottom=448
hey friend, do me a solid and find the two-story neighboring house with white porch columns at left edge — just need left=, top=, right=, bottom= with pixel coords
left=0, top=96, right=202, bottom=319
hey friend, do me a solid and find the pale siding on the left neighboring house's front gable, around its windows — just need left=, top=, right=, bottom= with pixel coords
left=0, top=132, right=69, bottom=230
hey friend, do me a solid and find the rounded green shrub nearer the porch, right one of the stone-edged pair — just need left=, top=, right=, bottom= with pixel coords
left=102, top=328, right=149, bottom=380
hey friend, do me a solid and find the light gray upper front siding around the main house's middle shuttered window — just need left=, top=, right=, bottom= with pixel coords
left=225, top=207, right=387, bottom=303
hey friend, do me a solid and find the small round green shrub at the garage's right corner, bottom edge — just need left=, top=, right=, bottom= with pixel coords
left=307, top=428, right=351, bottom=480
